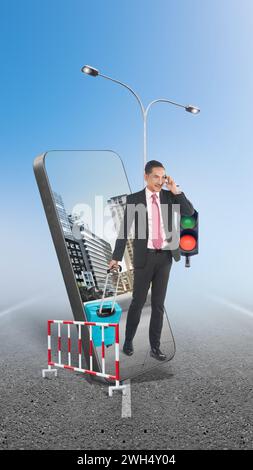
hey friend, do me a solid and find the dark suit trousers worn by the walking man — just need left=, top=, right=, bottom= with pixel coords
left=125, top=250, right=173, bottom=348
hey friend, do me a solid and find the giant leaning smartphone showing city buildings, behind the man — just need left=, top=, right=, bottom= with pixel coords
left=34, top=150, right=175, bottom=383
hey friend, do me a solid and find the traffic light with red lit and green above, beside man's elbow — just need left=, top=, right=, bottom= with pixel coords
left=179, top=210, right=199, bottom=268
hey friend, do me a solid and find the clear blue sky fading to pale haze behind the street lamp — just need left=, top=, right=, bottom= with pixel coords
left=0, top=0, right=253, bottom=312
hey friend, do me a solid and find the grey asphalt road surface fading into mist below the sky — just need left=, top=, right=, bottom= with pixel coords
left=0, top=292, right=253, bottom=450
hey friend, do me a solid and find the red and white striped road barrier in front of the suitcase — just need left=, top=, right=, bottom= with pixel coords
left=42, top=320, right=126, bottom=396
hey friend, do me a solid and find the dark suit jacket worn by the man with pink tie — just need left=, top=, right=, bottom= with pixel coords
left=112, top=188, right=194, bottom=268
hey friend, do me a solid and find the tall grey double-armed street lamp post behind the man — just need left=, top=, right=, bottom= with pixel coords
left=81, top=65, right=200, bottom=185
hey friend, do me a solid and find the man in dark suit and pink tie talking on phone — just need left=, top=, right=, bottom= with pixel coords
left=109, top=160, right=194, bottom=361
